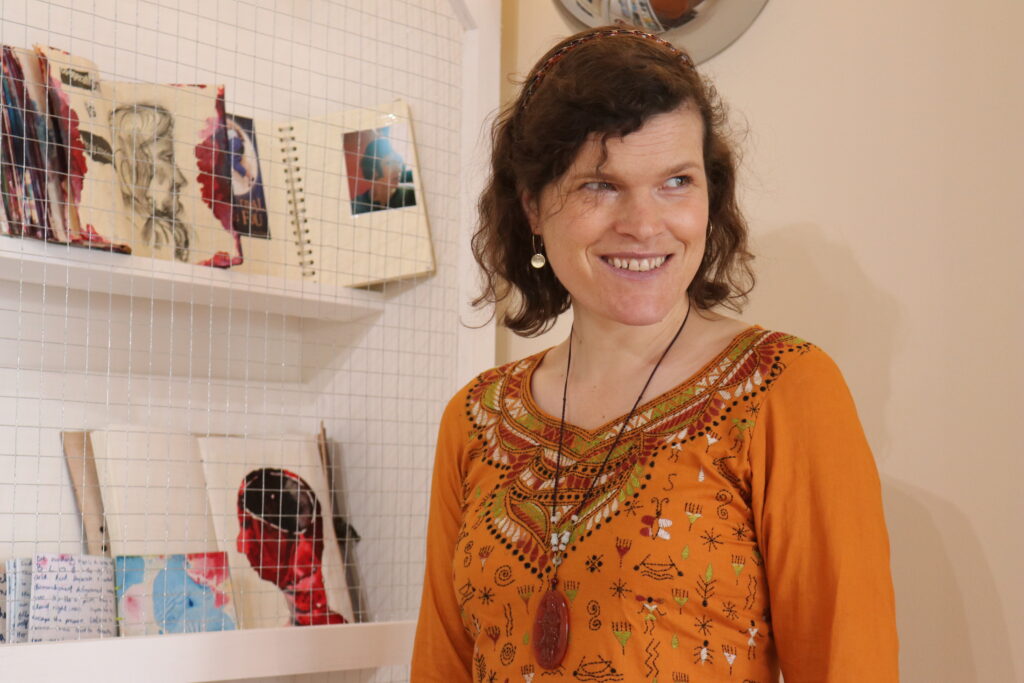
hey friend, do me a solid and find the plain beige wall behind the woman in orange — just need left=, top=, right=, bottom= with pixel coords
left=498, top=0, right=1024, bottom=683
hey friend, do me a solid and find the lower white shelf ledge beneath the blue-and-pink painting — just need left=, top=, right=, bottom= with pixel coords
left=0, top=622, right=416, bottom=683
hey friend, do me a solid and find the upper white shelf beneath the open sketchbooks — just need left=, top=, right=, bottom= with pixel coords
left=0, top=237, right=384, bottom=322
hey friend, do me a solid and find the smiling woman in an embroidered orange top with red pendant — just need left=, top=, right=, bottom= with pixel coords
left=412, top=28, right=897, bottom=683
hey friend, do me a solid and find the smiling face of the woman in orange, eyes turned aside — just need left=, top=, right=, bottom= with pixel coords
left=523, top=105, right=708, bottom=325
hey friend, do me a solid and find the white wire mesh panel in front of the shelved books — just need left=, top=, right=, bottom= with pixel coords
left=0, top=0, right=463, bottom=681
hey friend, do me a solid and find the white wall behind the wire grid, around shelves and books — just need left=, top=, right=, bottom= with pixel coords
left=0, top=0, right=477, bottom=682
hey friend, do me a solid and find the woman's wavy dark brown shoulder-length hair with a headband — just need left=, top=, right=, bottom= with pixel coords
left=472, top=27, right=754, bottom=336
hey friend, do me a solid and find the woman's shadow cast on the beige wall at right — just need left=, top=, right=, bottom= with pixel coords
left=748, top=224, right=1019, bottom=683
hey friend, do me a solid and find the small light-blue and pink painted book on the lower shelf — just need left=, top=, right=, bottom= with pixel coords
left=115, top=553, right=236, bottom=636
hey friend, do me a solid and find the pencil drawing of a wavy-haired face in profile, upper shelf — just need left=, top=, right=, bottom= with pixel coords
left=111, top=103, right=194, bottom=261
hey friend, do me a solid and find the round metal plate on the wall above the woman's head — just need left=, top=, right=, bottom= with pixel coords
left=554, top=0, right=768, bottom=63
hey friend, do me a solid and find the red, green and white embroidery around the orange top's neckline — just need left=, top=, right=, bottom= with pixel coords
left=466, top=326, right=807, bottom=574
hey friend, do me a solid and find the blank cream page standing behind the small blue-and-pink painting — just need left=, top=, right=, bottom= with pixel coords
left=90, top=426, right=218, bottom=555
